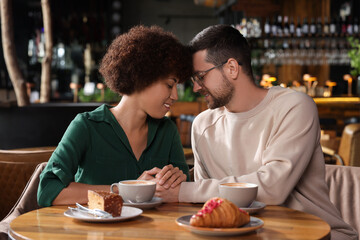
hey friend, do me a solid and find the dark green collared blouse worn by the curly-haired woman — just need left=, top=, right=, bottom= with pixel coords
left=37, top=105, right=189, bottom=206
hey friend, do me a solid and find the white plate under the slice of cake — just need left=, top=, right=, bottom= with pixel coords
left=64, top=206, right=143, bottom=222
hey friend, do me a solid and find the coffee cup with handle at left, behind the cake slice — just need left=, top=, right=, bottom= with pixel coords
left=110, top=180, right=156, bottom=203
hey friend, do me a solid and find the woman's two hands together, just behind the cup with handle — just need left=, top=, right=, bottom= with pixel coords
left=138, top=164, right=186, bottom=189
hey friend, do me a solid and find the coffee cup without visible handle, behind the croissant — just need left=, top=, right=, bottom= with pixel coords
left=219, top=183, right=258, bottom=208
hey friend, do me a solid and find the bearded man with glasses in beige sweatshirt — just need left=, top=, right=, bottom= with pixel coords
left=157, top=25, right=357, bottom=239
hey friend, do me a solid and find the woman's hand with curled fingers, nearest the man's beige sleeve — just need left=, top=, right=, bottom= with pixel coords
left=155, top=164, right=186, bottom=189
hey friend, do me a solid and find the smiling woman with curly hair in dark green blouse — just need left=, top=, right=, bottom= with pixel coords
left=38, top=26, right=192, bottom=206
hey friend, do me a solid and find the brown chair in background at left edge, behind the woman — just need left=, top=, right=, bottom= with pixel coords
left=0, top=149, right=53, bottom=219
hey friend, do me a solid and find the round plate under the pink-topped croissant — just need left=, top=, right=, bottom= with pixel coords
left=176, top=215, right=264, bottom=236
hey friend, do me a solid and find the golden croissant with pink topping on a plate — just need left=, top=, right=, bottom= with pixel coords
left=190, top=197, right=250, bottom=228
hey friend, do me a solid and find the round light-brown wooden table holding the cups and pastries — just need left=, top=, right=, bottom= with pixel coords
left=9, top=203, right=330, bottom=240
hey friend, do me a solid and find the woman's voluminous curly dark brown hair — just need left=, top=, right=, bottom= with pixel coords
left=99, top=25, right=193, bottom=95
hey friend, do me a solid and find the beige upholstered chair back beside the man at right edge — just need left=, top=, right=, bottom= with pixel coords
left=325, top=164, right=360, bottom=232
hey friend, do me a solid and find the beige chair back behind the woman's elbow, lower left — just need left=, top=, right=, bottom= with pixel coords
left=0, top=162, right=47, bottom=239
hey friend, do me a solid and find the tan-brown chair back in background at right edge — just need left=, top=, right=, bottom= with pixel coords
left=338, top=123, right=360, bottom=167
